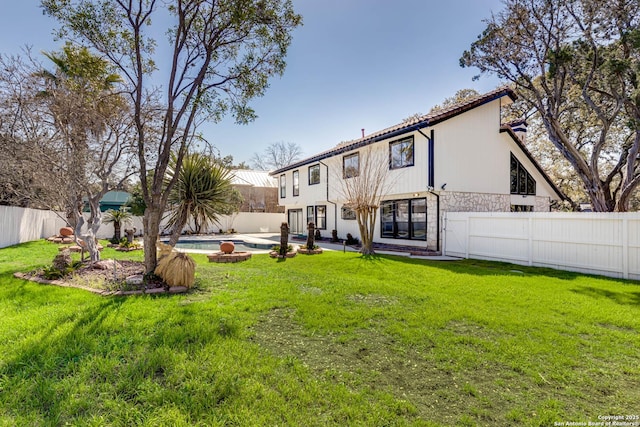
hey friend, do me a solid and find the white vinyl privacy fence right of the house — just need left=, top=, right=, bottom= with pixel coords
left=443, top=212, right=640, bottom=280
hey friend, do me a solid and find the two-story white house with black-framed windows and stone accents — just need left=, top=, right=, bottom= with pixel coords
left=271, top=88, right=564, bottom=251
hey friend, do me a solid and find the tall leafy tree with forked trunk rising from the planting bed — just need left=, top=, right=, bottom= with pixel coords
left=42, top=0, right=301, bottom=272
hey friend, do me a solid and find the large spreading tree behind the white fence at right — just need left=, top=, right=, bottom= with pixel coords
left=460, top=0, right=640, bottom=211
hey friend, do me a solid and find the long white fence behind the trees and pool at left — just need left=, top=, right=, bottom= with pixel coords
left=0, top=206, right=286, bottom=248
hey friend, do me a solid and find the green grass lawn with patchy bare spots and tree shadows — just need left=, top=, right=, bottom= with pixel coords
left=0, top=242, right=640, bottom=426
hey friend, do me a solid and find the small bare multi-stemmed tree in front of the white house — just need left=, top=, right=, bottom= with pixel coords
left=334, top=145, right=400, bottom=255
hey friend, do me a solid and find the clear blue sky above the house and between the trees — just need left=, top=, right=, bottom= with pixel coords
left=0, top=0, right=508, bottom=166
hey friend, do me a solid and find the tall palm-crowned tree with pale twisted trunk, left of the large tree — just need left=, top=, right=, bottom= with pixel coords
left=36, top=44, right=135, bottom=262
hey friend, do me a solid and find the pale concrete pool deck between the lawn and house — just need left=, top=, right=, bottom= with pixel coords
left=170, top=233, right=461, bottom=261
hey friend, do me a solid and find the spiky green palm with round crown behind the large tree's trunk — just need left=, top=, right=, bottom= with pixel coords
left=165, top=153, right=237, bottom=246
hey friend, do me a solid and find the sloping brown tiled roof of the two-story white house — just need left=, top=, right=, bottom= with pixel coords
left=271, top=87, right=517, bottom=175
